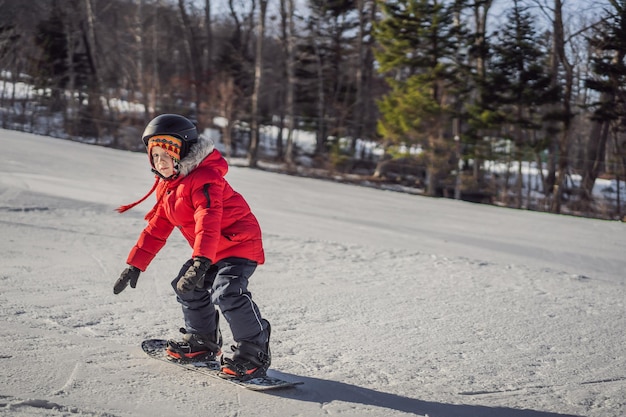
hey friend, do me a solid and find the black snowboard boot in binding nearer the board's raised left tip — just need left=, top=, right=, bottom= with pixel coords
left=165, top=318, right=222, bottom=361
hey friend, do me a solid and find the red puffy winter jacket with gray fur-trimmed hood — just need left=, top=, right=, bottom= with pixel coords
left=126, top=138, right=265, bottom=271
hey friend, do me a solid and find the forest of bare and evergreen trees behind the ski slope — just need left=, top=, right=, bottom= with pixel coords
left=0, top=0, right=626, bottom=219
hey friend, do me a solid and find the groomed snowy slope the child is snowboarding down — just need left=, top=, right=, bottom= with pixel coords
left=0, top=130, right=626, bottom=417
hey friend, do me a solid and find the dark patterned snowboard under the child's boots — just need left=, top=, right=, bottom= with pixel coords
left=141, top=339, right=303, bottom=391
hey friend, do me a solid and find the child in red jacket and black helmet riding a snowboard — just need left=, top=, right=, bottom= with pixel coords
left=113, top=114, right=271, bottom=380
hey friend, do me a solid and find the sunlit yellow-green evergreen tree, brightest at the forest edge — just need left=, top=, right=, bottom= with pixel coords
left=375, top=0, right=463, bottom=195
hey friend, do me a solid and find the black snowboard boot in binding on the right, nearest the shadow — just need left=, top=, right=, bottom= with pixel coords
left=219, top=319, right=272, bottom=381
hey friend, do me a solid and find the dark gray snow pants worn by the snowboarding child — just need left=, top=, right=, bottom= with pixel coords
left=172, top=258, right=267, bottom=345
